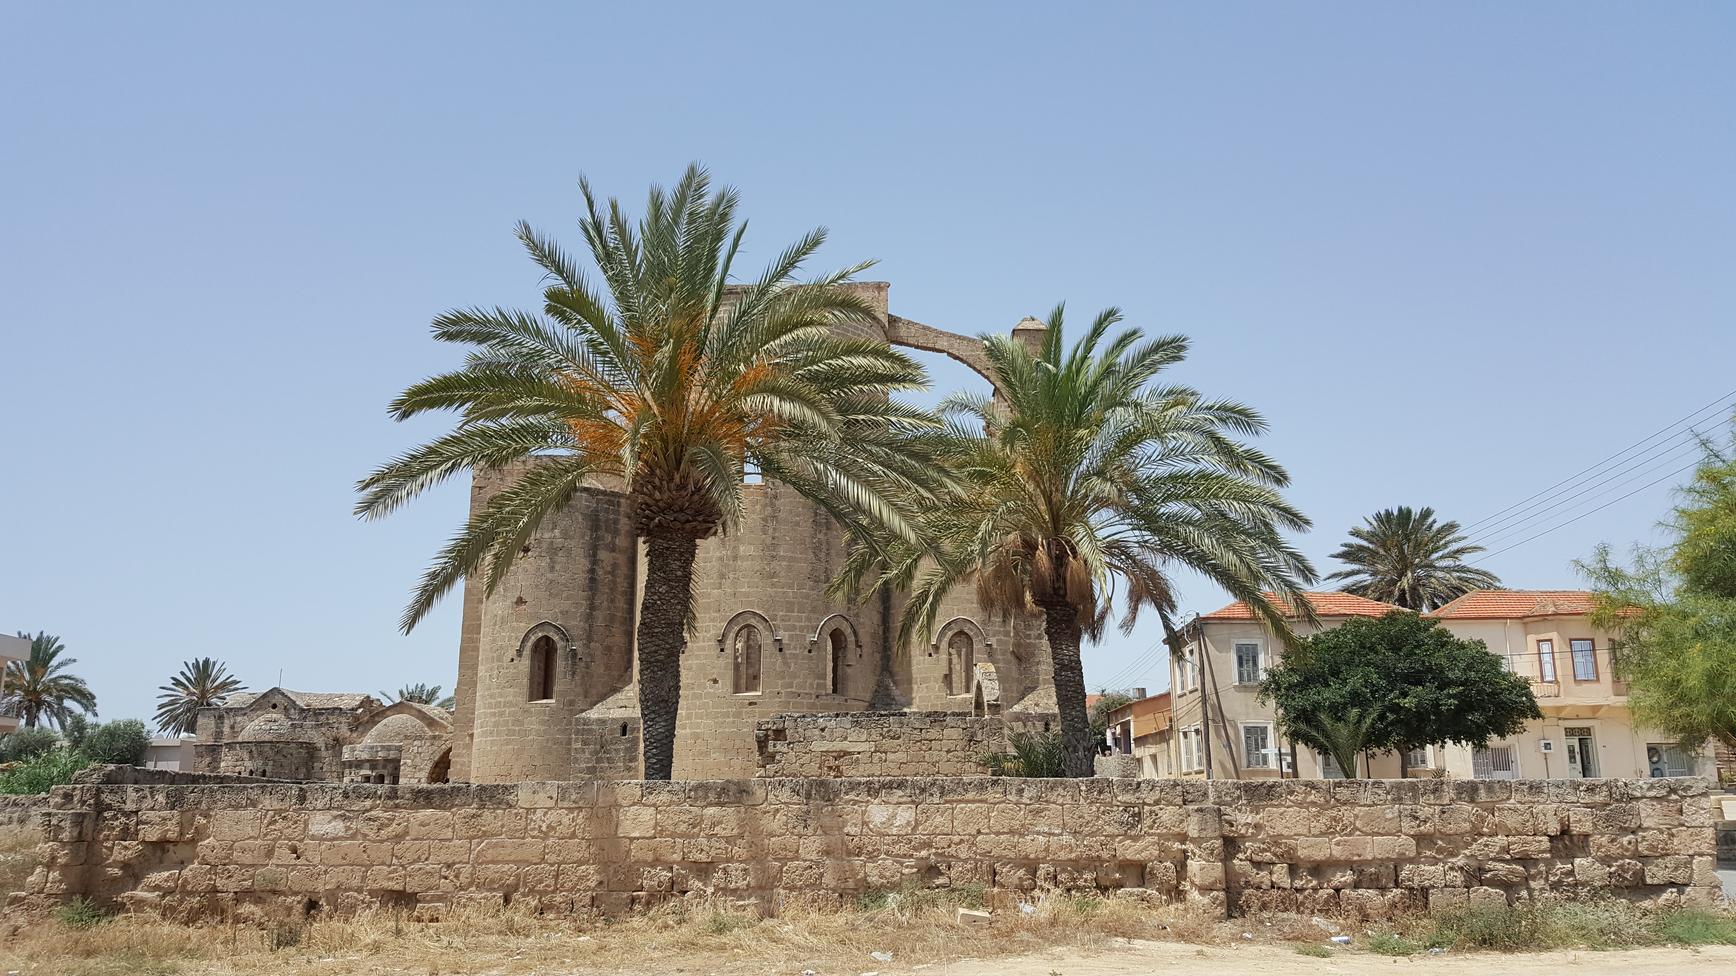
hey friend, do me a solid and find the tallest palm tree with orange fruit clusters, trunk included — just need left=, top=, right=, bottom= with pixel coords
left=356, top=167, right=937, bottom=780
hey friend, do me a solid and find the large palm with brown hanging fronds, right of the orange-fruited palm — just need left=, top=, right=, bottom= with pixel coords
left=840, top=307, right=1314, bottom=776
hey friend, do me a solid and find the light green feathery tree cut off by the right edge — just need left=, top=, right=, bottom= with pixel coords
left=1578, top=422, right=1736, bottom=748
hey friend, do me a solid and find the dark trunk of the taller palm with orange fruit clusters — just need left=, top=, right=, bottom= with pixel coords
left=639, top=535, right=700, bottom=780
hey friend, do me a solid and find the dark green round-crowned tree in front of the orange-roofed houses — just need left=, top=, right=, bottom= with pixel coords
left=1260, top=610, right=1543, bottom=775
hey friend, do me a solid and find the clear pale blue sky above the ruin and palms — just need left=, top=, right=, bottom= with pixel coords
left=0, top=2, right=1736, bottom=719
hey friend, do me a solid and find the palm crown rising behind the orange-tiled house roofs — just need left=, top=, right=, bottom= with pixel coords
left=1326, top=505, right=1502, bottom=613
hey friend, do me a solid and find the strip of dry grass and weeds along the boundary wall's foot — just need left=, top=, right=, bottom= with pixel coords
left=0, top=889, right=1736, bottom=976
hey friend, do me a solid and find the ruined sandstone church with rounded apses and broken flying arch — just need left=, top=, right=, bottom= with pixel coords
left=451, top=281, right=1054, bottom=783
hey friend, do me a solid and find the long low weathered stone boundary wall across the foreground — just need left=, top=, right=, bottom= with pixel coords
left=14, top=776, right=1719, bottom=919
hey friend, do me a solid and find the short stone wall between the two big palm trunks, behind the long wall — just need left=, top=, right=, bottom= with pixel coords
left=753, top=712, right=1007, bottom=778
